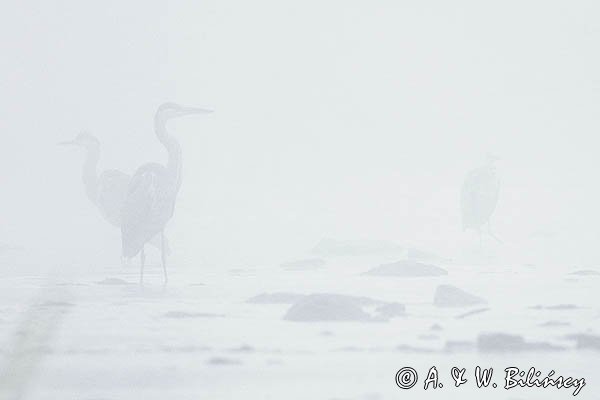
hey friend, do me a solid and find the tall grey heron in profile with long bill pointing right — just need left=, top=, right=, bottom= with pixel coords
left=121, top=103, right=212, bottom=284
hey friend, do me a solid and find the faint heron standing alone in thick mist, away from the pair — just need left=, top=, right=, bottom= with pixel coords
left=460, top=155, right=500, bottom=244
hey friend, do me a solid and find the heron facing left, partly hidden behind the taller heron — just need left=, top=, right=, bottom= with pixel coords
left=59, top=132, right=170, bottom=253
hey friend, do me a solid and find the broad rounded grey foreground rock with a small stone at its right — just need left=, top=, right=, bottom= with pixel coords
left=283, top=293, right=373, bottom=322
